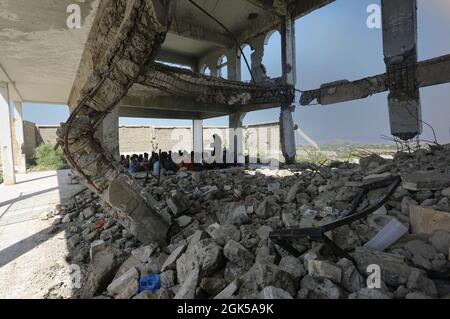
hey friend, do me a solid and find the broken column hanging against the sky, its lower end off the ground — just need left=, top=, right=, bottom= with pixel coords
left=381, top=0, right=423, bottom=140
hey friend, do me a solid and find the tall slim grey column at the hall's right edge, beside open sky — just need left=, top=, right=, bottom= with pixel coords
left=280, top=15, right=297, bottom=163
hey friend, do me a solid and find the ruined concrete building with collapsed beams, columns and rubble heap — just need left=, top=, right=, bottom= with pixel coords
left=0, top=0, right=450, bottom=299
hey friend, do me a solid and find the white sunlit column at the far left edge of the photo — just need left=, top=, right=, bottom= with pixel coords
left=0, top=82, right=16, bottom=185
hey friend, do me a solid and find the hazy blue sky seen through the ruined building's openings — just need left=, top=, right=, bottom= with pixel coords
left=24, top=0, right=450, bottom=143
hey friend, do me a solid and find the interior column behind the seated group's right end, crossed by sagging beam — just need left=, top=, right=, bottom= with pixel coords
left=227, top=50, right=246, bottom=164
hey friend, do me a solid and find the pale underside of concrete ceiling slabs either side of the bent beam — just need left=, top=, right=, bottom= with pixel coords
left=0, top=0, right=334, bottom=104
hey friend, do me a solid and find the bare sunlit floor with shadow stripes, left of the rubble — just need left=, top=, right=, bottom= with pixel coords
left=0, top=171, right=83, bottom=299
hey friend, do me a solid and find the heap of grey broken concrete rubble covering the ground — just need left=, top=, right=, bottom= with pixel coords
left=48, top=145, right=450, bottom=299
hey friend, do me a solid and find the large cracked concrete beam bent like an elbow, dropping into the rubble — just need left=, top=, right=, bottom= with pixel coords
left=58, top=0, right=175, bottom=248
